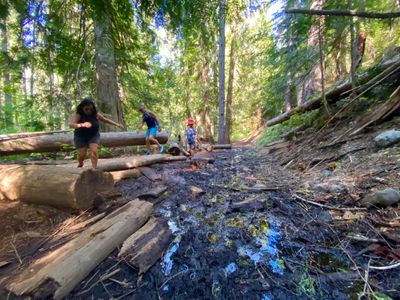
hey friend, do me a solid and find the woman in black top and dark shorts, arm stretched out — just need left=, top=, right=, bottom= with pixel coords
left=69, top=98, right=124, bottom=169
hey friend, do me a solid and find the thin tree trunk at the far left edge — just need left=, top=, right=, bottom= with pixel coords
left=0, top=18, right=13, bottom=126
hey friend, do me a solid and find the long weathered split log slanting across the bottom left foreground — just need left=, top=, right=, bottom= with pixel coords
left=7, top=200, right=153, bottom=299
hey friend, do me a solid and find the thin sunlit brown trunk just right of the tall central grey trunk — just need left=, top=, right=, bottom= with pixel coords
left=224, top=18, right=236, bottom=144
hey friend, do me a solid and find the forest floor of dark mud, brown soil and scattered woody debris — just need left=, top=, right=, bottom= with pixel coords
left=0, top=116, right=400, bottom=299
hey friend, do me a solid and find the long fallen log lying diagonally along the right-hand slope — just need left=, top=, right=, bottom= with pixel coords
left=265, top=55, right=400, bottom=126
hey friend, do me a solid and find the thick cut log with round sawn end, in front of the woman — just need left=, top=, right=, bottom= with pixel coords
left=0, top=165, right=114, bottom=210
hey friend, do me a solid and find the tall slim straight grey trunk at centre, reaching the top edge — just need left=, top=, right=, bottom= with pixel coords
left=218, top=0, right=225, bottom=144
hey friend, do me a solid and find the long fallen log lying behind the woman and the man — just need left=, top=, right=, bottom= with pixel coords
left=0, top=131, right=168, bottom=155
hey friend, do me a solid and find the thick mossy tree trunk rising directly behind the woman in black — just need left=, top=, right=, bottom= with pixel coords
left=93, top=0, right=124, bottom=131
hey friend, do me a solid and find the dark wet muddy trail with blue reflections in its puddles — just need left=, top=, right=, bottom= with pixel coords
left=50, top=147, right=400, bottom=299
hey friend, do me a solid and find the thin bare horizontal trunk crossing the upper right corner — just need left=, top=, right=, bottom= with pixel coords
left=285, top=8, right=400, bottom=19
